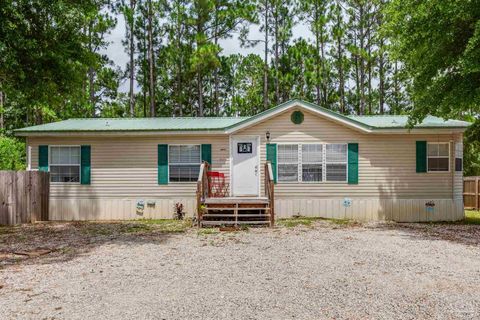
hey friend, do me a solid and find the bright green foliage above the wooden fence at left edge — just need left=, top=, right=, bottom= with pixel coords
left=0, top=136, right=26, bottom=170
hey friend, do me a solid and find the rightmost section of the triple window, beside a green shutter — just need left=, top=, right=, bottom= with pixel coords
left=325, top=144, right=347, bottom=181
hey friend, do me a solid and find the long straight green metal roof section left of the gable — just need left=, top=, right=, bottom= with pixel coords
left=16, top=117, right=248, bottom=133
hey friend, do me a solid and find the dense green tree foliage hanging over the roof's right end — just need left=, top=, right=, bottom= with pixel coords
left=386, top=0, right=480, bottom=120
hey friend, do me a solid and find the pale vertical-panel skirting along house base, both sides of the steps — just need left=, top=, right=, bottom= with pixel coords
left=50, top=198, right=464, bottom=222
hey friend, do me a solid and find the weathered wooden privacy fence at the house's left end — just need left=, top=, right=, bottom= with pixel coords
left=0, top=171, right=50, bottom=225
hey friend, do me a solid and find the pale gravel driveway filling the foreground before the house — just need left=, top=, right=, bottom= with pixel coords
left=0, top=222, right=480, bottom=319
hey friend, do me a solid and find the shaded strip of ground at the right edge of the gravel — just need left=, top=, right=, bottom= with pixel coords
left=371, top=222, right=480, bottom=246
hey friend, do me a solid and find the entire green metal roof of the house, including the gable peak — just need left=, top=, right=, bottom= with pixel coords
left=15, top=99, right=470, bottom=135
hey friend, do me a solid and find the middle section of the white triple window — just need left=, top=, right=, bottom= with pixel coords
left=302, top=144, right=323, bottom=182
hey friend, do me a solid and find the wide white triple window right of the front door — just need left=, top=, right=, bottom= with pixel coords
left=277, top=144, right=348, bottom=182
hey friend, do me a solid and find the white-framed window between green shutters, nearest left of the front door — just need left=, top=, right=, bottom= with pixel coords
left=168, top=145, right=202, bottom=182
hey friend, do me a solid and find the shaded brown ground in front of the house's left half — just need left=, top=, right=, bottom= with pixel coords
left=0, top=220, right=191, bottom=269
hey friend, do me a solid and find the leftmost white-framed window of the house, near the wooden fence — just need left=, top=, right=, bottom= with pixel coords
left=48, top=146, right=80, bottom=183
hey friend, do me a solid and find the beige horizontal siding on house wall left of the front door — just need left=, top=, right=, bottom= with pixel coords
left=27, top=135, right=229, bottom=199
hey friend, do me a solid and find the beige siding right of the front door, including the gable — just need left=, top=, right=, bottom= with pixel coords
left=235, top=110, right=460, bottom=199
